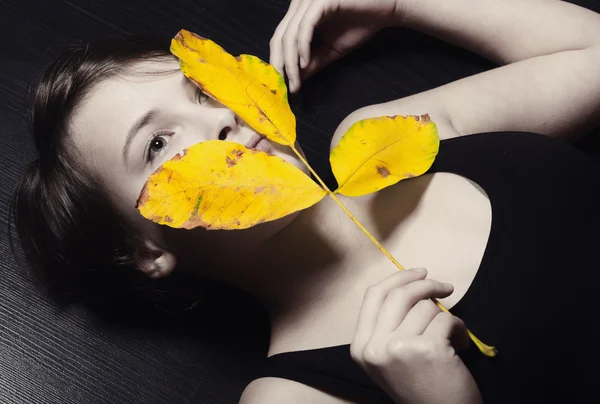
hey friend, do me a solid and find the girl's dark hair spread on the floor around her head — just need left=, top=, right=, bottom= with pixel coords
left=11, top=36, right=217, bottom=318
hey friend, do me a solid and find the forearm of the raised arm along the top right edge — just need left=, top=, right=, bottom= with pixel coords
left=399, top=0, right=600, bottom=64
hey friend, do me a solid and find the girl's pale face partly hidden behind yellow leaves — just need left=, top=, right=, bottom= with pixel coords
left=70, top=60, right=306, bottom=278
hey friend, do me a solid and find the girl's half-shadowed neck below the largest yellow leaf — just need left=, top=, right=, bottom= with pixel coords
left=227, top=198, right=382, bottom=323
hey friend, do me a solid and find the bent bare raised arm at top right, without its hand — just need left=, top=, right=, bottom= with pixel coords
left=333, top=0, right=600, bottom=144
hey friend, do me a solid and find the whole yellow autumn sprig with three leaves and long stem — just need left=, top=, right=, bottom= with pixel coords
left=156, top=30, right=496, bottom=356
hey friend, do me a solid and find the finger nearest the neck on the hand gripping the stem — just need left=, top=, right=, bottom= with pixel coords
left=350, top=268, right=427, bottom=360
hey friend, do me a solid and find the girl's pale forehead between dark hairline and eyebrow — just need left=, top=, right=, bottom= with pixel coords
left=69, top=59, right=189, bottom=207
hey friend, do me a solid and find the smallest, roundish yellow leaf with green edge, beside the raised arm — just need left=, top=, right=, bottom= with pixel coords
left=329, top=115, right=440, bottom=196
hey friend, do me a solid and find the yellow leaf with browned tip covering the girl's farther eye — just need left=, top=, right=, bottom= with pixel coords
left=171, top=30, right=296, bottom=145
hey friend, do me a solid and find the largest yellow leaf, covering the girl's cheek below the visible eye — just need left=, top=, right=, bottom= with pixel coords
left=137, top=140, right=326, bottom=230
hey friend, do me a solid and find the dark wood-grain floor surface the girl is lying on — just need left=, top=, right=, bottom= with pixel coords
left=0, top=0, right=600, bottom=404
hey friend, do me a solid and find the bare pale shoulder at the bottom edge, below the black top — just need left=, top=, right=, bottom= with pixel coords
left=239, top=377, right=357, bottom=404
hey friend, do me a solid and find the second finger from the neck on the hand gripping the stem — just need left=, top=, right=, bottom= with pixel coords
left=372, top=279, right=454, bottom=339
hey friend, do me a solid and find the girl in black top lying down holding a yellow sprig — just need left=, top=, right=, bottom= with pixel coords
left=15, top=0, right=600, bottom=404
